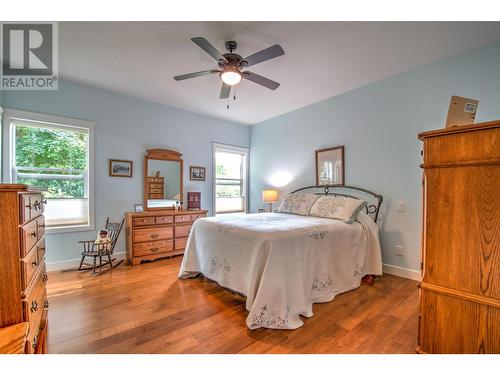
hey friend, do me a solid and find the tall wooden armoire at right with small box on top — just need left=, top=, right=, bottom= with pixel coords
left=417, top=121, right=500, bottom=353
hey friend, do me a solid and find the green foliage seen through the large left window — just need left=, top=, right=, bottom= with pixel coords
left=15, top=126, right=87, bottom=198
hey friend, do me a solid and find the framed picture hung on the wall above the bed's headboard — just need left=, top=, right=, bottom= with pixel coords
left=316, top=146, right=345, bottom=186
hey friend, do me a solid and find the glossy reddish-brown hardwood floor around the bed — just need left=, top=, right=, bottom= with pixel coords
left=47, top=257, right=418, bottom=353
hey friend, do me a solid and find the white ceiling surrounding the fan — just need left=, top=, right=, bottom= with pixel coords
left=59, top=22, right=500, bottom=124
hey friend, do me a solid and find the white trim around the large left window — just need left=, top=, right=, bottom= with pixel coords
left=2, top=108, right=95, bottom=233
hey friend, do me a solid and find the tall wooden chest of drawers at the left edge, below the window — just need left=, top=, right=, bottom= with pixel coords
left=0, top=184, right=49, bottom=353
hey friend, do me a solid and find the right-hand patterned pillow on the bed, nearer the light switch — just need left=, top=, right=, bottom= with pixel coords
left=310, top=195, right=366, bottom=223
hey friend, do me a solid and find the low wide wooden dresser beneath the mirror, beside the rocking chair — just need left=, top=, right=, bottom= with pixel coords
left=129, top=210, right=207, bottom=265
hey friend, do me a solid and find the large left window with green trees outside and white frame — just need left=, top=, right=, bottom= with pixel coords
left=2, top=111, right=93, bottom=230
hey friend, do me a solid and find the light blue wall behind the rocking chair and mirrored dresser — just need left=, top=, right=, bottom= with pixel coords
left=3, top=82, right=250, bottom=263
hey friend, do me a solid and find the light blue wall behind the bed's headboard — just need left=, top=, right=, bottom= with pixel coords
left=250, top=44, right=500, bottom=270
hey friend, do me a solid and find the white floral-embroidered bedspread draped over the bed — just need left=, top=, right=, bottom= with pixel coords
left=179, top=213, right=382, bottom=329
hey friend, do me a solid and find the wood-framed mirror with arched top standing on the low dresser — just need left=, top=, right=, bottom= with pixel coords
left=144, top=149, right=183, bottom=210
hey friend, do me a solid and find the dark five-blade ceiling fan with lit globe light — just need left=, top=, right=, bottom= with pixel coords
left=174, top=37, right=285, bottom=99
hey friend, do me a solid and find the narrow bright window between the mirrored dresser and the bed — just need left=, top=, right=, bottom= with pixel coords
left=213, top=144, right=248, bottom=214
